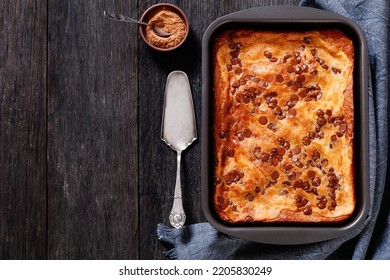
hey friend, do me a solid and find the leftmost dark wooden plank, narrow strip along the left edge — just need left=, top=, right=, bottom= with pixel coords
left=0, top=0, right=47, bottom=259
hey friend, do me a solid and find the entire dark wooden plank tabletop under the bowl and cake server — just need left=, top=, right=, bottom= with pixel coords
left=0, top=0, right=299, bottom=259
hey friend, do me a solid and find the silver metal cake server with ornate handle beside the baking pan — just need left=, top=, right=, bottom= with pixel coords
left=161, top=71, right=197, bottom=228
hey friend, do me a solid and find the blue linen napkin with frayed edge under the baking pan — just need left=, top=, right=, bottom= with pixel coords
left=157, top=0, right=390, bottom=260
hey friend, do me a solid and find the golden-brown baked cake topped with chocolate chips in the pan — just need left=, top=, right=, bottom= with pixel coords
left=213, top=29, right=355, bottom=223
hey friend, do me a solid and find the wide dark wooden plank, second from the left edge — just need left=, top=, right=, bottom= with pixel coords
left=47, top=0, right=139, bottom=259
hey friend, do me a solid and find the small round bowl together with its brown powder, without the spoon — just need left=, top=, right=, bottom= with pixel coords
left=140, top=3, right=189, bottom=51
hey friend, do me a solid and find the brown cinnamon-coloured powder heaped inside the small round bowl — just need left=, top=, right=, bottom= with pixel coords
left=144, top=9, right=187, bottom=49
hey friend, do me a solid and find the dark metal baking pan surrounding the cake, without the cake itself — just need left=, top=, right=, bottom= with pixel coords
left=201, top=6, right=370, bottom=244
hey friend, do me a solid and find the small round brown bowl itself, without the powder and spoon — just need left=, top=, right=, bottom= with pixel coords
left=139, top=3, right=190, bottom=52
